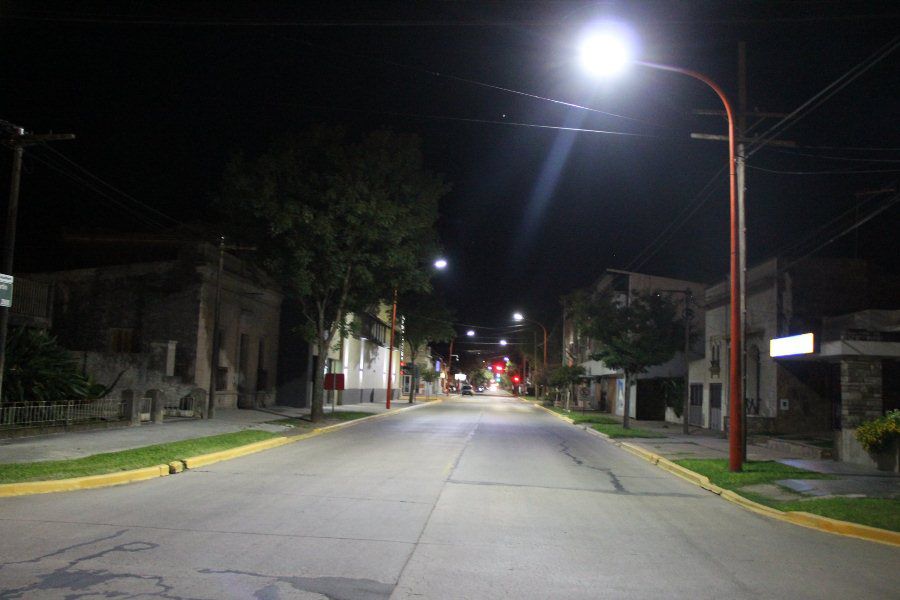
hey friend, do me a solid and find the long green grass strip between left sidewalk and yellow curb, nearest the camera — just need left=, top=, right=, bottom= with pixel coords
left=0, top=430, right=279, bottom=483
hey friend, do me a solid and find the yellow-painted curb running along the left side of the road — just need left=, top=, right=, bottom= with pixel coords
left=0, top=398, right=442, bottom=498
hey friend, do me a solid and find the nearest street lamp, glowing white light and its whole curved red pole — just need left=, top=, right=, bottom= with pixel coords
left=581, top=29, right=744, bottom=472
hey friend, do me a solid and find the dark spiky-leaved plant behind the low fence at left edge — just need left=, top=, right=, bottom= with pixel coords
left=3, top=327, right=97, bottom=402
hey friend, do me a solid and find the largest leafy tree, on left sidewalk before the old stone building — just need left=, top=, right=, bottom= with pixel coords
left=217, top=126, right=449, bottom=421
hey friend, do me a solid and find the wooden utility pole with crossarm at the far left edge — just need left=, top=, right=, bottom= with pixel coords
left=0, top=121, right=75, bottom=402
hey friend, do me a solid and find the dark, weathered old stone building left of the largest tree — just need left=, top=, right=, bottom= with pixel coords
left=28, top=239, right=282, bottom=411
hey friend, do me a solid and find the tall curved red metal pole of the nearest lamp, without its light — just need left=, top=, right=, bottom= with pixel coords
left=638, top=61, right=744, bottom=472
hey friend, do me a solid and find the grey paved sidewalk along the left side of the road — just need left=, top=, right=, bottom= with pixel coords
left=0, top=399, right=436, bottom=463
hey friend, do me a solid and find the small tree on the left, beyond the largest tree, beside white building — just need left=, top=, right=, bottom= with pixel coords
left=398, top=292, right=456, bottom=404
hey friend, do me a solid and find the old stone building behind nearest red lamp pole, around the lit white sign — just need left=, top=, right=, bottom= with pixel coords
left=690, top=258, right=900, bottom=462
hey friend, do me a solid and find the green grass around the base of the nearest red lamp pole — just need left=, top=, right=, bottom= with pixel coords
left=675, top=459, right=900, bottom=531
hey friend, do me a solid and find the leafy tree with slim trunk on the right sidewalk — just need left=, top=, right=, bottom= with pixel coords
left=572, top=291, right=683, bottom=428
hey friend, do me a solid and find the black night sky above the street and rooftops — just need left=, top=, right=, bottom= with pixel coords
left=0, top=1, right=900, bottom=346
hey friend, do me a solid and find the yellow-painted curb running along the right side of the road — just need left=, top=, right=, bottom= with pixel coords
left=529, top=402, right=900, bottom=546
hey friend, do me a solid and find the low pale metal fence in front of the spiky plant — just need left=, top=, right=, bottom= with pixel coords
left=0, top=398, right=126, bottom=430
